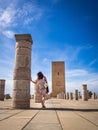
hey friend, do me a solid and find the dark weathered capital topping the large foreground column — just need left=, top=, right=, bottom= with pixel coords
left=15, top=34, right=33, bottom=44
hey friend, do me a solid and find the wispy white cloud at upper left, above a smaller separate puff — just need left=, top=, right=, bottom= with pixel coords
left=0, top=2, right=43, bottom=28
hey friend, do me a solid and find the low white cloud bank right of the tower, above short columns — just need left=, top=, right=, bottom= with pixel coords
left=66, top=69, right=98, bottom=93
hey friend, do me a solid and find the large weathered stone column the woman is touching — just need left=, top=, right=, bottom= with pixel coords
left=12, top=34, right=32, bottom=108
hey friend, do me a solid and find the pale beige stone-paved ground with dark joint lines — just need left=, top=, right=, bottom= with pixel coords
left=0, top=99, right=98, bottom=130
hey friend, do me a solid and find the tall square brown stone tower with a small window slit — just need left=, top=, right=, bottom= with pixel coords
left=52, top=62, right=65, bottom=97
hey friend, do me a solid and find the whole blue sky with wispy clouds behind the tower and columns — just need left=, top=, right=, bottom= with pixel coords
left=0, top=0, right=98, bottom=93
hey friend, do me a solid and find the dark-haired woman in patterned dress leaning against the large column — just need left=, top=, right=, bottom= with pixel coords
left=31, top=72, right=46, bottom=108
